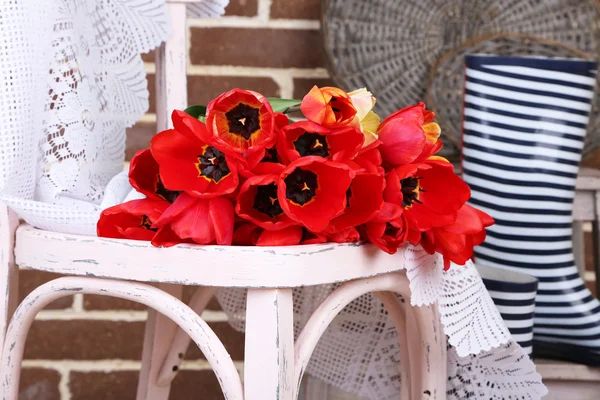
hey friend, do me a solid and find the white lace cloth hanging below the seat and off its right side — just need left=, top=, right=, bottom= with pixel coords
left=217, top=246, right=546, bottom=400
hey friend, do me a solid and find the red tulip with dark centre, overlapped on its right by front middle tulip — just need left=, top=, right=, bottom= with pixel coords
left=235, top=173, right=297, bottom=231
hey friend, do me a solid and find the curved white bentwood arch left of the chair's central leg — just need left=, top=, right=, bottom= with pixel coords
left=0, top=277, right=244, bottom=400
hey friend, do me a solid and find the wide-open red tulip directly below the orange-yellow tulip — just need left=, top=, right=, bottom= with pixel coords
left=278, top=121, right=365, bottom=161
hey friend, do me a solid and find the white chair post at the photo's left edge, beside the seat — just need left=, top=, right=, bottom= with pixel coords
left=0, top=203, right=19, bottom=354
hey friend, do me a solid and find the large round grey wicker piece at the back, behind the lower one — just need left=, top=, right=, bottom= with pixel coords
left=322, top=0, right=600, bottom=155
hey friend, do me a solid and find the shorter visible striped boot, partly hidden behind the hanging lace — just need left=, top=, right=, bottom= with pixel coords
left=475, top=265, right=538, bottom=356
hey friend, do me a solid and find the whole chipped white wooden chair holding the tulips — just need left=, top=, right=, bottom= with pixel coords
left=0, top=0, right=446, bottom=400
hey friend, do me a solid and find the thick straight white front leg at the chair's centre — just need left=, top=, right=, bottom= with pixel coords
left=244, top=289, right=296, bottom=400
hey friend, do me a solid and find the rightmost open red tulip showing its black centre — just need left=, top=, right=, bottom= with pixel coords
left=384, top=161, right=471, bottom=232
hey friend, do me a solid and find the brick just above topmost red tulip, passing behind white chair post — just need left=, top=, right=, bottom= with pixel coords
left=148, top=75, right=280, bottom=113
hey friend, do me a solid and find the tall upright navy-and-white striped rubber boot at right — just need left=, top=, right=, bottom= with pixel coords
left=463, top=56, right=600, bottom=365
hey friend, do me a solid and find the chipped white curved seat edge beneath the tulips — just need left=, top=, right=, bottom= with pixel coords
left=15, top=224, right=405, bottom=288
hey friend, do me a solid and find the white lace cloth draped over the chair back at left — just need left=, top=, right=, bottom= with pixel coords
left=0, top=0, right=229, bottom=235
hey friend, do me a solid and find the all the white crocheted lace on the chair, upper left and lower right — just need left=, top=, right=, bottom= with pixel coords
left=0, top=0, right=545, bottom=400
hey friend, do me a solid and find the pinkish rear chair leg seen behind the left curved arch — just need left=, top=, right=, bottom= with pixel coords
left=136, top=283, right=183, bottom=400
